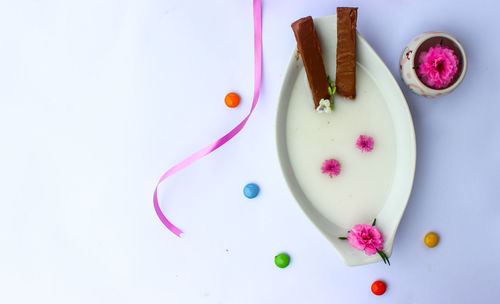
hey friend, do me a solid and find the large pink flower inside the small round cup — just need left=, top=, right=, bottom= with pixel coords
left=417, top=44, right=458, bottom=89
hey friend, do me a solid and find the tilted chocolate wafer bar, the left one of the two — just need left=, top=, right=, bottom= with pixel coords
left=292, top=16, right=330, bottom=108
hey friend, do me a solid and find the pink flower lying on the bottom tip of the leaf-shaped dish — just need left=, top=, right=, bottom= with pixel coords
left=347, top=224, right=384, bottom=255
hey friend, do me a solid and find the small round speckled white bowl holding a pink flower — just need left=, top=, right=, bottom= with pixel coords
left=399, top=32, right=467, bottom=97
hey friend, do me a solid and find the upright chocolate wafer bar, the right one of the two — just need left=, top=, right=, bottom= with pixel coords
left=335, top=7, right=358, bottom=99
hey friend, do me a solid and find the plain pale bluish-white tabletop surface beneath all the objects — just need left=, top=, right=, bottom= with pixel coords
left=0, top=0, right=500, bottom=304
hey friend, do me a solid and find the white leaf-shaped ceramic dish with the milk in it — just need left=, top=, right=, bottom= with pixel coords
left=276, top=15, right=416, bottom=265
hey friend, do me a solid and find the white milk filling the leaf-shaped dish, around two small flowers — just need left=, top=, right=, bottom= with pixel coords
left=286, top=64, right=396, bottom=229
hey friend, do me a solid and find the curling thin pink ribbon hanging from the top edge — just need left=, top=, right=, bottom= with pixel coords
left=153, top=0, right=262, bottom=237
